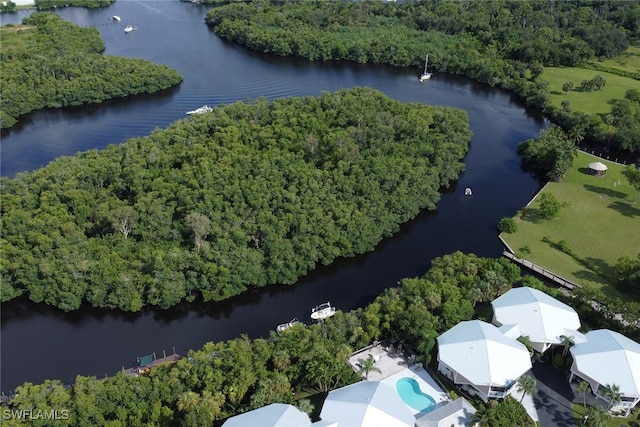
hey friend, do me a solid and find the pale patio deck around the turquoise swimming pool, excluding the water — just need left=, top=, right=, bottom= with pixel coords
left=349, top=344, right=449, bottom=416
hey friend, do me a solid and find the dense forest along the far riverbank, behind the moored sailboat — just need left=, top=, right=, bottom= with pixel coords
left=206, top=1, right=640, bottom=151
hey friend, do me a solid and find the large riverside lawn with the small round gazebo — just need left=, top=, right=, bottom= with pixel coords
left=501, top=152, right=640, bottom=301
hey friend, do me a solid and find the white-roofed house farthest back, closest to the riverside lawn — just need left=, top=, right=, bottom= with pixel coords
left=491, top=287, right=582, bottom=353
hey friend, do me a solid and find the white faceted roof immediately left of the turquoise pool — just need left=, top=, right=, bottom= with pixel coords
left=316, top=381, right=415, bottom=427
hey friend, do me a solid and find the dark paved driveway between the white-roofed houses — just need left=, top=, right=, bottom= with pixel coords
left=531, top=363, right=576, bottom=427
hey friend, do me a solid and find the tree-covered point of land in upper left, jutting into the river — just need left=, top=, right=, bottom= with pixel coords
left=0, top=12, right=182, bottom=128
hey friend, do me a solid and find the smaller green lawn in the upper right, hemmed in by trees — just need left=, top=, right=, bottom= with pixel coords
left=541, top=67, right=640, bottom=114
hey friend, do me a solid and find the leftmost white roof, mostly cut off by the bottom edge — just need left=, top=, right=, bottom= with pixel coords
left=222, top=403, right=311, bottom=427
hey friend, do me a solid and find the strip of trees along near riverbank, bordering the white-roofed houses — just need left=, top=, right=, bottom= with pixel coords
left=5, top=252, right=639, bottom=426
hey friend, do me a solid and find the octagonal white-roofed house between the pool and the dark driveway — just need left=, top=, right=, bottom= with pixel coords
left=437, top=320, right=531, bottom=401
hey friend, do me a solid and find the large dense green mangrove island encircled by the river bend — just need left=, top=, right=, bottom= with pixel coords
left=0, top=88, right=471, bottom=311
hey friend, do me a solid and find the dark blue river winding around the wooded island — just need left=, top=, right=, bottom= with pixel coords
left=0, top=0, right=545, bottom=392
